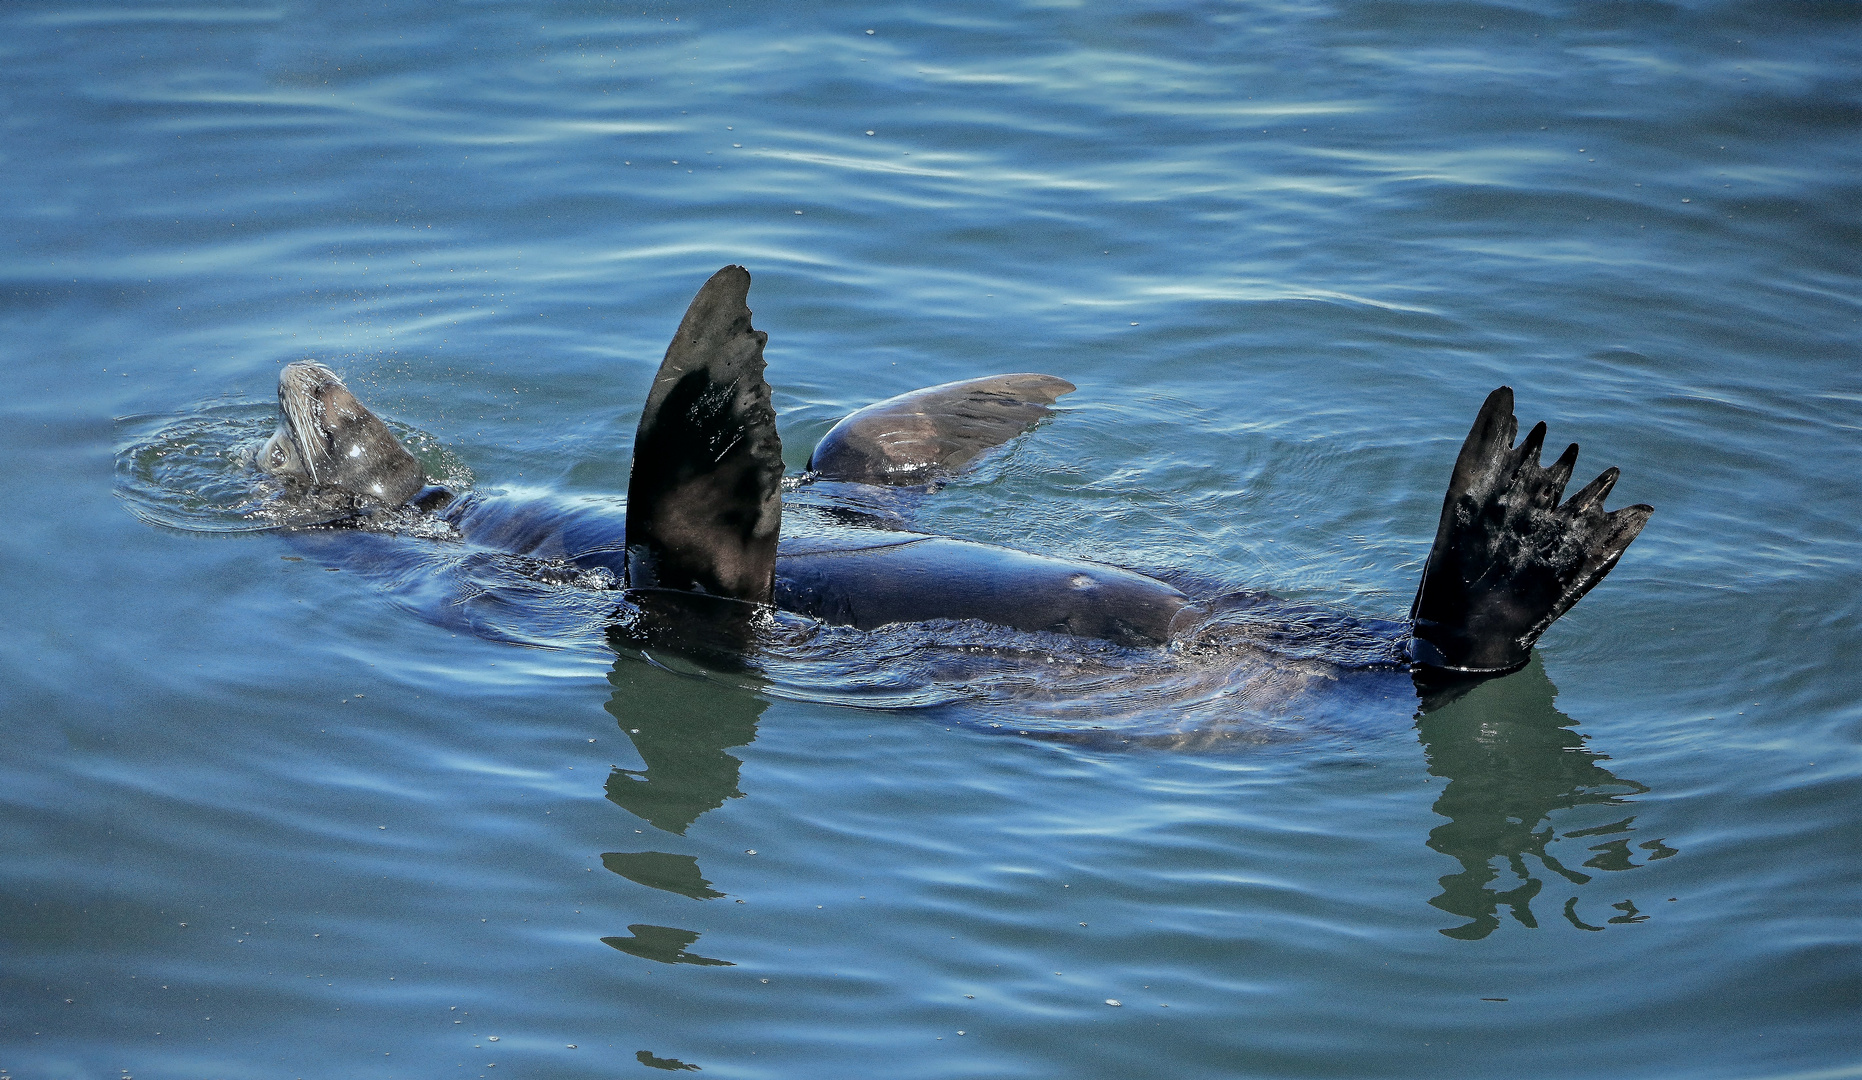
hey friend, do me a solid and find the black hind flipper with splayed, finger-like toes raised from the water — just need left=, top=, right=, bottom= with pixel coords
left=1410, top=385, right=1655, bottom=674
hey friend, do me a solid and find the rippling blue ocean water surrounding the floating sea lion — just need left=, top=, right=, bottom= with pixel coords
left=0, top=0, right=1862, bottom=1080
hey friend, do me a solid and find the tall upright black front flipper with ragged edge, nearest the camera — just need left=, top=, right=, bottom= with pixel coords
left=627, top=266, right=782, bottom=603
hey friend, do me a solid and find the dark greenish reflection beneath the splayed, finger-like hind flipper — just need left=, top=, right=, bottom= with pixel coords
left=1417, top=657, right=1676, bottom=940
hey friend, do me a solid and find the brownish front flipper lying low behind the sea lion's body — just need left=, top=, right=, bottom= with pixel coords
left=808, top=374, right=1074, bottom=486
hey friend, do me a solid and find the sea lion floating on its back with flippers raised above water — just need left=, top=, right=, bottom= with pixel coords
left=268, top=266, right=1652, bottom=682
